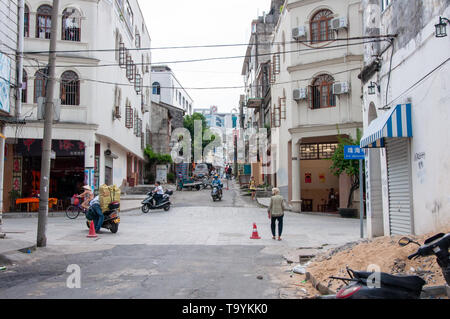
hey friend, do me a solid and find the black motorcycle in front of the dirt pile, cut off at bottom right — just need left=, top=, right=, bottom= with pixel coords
left=330, top=233, right=450, bottom=299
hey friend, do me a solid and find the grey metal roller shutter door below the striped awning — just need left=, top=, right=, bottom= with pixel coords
left=386, top=138, right=412, bottom=235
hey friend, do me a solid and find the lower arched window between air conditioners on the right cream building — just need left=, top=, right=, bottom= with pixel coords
left=309, top=74, right=336, bottom=109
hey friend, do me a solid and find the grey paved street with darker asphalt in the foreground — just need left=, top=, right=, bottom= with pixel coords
left=0, top=182, right=359, bottom=299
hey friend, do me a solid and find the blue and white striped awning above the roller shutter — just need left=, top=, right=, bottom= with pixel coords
left=360, top=104, right=412, bottom=148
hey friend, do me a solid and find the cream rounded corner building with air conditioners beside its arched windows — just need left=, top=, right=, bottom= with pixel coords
left=271, top=0, right=363, bottom=215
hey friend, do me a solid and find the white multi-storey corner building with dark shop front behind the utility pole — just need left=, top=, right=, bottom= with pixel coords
left=5, top=0, right=151, bottom=208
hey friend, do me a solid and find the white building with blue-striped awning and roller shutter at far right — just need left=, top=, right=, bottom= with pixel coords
left=360, top=0, right=450, bottom=237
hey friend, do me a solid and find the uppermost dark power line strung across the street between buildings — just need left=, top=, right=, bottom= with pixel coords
left=24, top=34, right=397, bottom=54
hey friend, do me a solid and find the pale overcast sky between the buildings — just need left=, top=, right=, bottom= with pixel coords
left=138, top=0, right=271, bottom=112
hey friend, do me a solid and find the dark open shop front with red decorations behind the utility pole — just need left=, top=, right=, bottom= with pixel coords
left=5, top=139, right=85, bottom=210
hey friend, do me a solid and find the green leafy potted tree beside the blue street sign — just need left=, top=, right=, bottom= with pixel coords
left=330, top=128, right=364, bottom=208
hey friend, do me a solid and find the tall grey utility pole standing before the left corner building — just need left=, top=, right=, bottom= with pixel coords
left=37, top=0, right=59, bottom=247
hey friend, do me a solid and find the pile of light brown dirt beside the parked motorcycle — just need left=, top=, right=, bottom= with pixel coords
left=307, top=226, right=450, bottom=292
